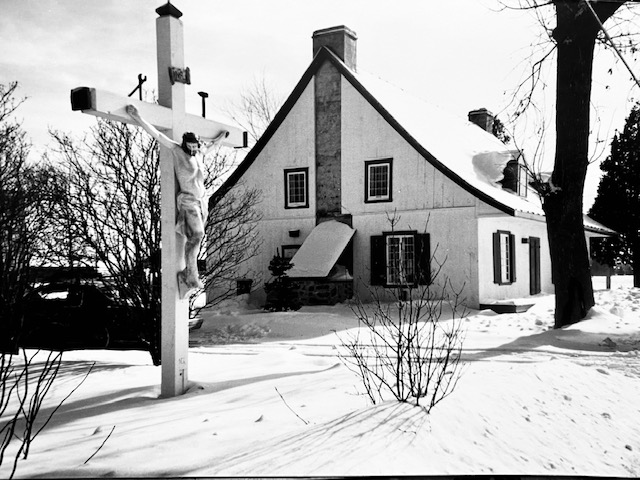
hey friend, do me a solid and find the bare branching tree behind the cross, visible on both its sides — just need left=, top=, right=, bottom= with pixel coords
left=51, top=120, right=258, bottom=326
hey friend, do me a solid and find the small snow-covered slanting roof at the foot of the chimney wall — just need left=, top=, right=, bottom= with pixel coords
left=287, top=220, right=356, bottom=278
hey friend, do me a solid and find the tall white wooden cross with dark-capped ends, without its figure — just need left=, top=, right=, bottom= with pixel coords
left=71, top=3, right=247, bottom=397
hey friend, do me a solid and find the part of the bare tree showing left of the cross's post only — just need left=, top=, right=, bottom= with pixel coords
left=50, top=120, right=160, bottom=364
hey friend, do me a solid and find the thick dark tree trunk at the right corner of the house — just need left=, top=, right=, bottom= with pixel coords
left=543, top=0, right=619, bottom=328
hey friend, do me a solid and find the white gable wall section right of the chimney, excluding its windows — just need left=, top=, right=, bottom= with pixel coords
left=342, top=78, right=478, bottom=304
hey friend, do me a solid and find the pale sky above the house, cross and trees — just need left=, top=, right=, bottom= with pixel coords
left=0, top=0, right=640, bottom=210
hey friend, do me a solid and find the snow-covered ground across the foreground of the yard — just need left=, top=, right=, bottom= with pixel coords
left=5, top=277, right=640, bottom=477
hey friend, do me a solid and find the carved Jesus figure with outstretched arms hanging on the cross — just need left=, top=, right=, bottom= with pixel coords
left=127, top=105, right=229, bottom=296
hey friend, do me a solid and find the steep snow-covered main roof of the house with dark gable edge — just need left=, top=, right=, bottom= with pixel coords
left=210, top=47, right=544, bottom=215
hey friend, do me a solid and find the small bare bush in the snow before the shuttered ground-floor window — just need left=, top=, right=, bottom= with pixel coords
left=339, top=218, right=467, bottom=412
